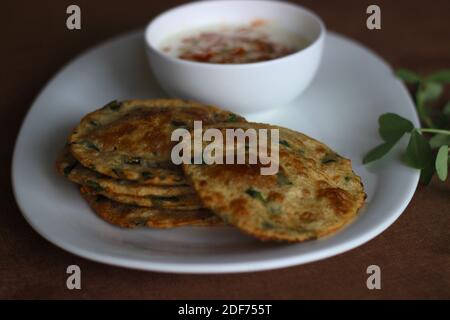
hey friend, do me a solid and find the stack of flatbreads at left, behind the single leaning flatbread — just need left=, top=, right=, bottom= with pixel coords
left=56, top=99, right=245, bottom=228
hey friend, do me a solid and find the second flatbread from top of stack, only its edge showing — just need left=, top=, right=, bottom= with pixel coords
left=56, top=148, right=194, bottom=197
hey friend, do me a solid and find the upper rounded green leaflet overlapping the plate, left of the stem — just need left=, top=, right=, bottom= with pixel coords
left=378, top=113, right=414, bottom=141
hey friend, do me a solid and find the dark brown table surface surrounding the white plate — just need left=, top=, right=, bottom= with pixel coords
left=0, top=0, right=450, bottom=299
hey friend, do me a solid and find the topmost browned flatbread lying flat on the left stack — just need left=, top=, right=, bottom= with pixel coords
left=68, top=99, right=245, bottom=180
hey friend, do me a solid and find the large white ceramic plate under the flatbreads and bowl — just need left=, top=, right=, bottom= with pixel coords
left=12, top=32, right=419, bottom=273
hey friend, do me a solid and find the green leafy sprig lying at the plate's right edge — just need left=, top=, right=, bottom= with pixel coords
left=363, top=69, right=450, bottom=184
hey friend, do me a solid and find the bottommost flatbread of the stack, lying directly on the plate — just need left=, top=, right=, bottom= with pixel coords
left=80, top=188, right=225, bottom=228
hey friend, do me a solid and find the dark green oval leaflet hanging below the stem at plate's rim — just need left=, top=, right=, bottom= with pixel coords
left=405, top=130, right=433, bottom=169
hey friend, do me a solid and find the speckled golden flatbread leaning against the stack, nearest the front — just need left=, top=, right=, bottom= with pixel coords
left=183, top=123, right=365, bottom=242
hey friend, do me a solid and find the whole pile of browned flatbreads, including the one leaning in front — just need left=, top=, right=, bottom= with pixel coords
left=56, top=99, right=365, bottom=242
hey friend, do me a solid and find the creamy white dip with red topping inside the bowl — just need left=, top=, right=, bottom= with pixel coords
left=164, top=21, right=298, bottom=64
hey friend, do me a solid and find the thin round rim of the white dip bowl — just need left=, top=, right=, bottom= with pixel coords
left=144, top=0, right=326, bottom=68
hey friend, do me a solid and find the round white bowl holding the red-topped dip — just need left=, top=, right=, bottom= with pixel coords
left=145, top=0, right=325, bottom=113
